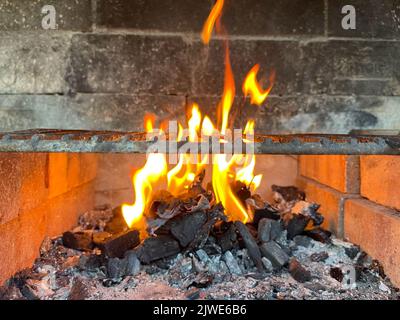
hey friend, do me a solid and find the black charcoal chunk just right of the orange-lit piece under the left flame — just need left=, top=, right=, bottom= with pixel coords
left=137, top=236, right=181, bottom=264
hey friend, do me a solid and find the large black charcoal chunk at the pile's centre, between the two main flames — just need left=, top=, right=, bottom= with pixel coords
left=171, top=211, right=207, bottom=247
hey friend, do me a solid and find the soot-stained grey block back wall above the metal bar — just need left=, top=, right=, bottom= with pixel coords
left=0, top=0, right=400, bottom=133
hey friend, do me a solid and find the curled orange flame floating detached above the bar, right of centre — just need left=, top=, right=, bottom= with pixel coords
left=242, top=64, right=275, bottom=106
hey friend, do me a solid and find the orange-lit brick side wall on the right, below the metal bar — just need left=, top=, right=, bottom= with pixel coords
left=298, top=155, right=400, bottom=285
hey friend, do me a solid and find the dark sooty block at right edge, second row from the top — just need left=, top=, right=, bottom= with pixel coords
left=301, top=40, right=400, bottom=96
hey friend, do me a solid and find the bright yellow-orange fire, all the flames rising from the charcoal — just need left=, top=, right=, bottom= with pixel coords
left=122, top=0, right=274, bottom=234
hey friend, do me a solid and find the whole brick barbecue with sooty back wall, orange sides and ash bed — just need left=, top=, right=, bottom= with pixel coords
left=0, top=0, right=400, bottom=300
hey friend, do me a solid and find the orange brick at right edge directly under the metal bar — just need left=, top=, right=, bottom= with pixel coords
left=360, top=156, right=400, bottom=210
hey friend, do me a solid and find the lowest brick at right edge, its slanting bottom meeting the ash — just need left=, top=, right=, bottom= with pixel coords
left=344, top=199, right=400, bottom=286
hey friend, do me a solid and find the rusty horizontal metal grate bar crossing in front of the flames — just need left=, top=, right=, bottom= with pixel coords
left=0, top=129, right=400, bottom=155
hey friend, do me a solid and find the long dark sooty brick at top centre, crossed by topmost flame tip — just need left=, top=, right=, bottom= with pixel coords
left=97, top=0, right=324, bottom=35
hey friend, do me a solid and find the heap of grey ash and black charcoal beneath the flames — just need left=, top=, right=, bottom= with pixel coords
left=0, top=183, right=400, bottom=300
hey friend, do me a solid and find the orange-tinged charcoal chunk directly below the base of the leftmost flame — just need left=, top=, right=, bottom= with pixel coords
left=99, top=230, right=140, bottom=258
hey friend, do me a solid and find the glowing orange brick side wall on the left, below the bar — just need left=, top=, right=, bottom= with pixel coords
left=0, top=153, right=97, bottom=284
